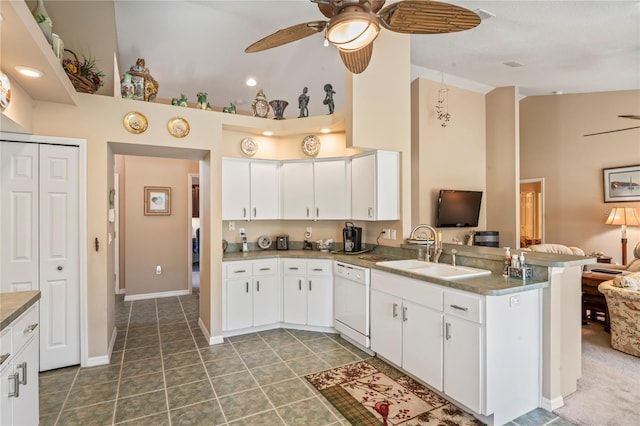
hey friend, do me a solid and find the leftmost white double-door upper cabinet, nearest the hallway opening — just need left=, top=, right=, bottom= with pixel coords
left=222, top=158, right=280, bottom=220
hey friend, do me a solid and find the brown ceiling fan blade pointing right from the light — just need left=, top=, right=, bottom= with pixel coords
left=378, top=0, right=480, bottom=34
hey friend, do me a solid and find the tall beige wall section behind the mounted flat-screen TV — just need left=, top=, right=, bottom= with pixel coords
left=411, top=79, right=487, bottom=242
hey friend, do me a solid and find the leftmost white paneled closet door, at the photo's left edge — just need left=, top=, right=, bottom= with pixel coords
left=0, top=142, right=40, bottom=292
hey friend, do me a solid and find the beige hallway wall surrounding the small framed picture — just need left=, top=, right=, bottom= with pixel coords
left=121, top=156, right=198, bottom=296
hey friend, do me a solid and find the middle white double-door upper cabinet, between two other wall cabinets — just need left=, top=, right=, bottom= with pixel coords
left=281, top=159, right=349, bottom=220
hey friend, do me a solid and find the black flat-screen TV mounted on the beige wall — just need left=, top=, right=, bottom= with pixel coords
left=436, top=189, right=482, bottom=228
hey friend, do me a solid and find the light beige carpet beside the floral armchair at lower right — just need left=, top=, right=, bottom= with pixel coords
left=554, top=323, right=640, bottom=426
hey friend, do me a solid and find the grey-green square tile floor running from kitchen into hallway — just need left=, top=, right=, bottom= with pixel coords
left=40, top=293, right=570, bottom=426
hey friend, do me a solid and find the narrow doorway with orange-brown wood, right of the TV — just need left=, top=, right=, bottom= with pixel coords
left=520, top=178, right=544, bottom=248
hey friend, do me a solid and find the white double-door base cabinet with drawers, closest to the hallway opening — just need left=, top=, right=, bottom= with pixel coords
left=223, top=259, right=280, bottom=331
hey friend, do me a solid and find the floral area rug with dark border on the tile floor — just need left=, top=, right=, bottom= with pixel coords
left=306, top=358, right=483, bottom=426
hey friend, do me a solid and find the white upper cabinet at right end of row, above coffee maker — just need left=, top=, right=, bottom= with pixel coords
left=351, top=151, right=400, bottom=220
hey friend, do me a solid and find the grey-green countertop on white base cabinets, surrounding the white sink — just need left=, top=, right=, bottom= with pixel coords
left=223, top=250, right=548, bottom=296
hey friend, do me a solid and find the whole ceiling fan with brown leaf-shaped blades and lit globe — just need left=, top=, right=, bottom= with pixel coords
left=245, top=0, right=480, bottom=74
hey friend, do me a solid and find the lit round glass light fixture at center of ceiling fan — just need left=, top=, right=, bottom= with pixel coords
left=327, top=12, right=380, bottom=51
